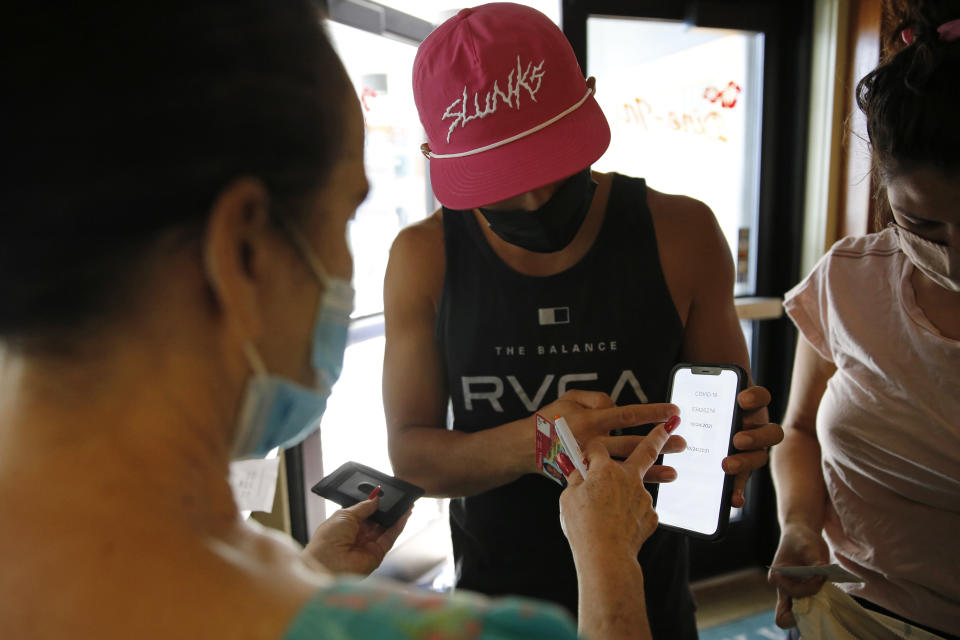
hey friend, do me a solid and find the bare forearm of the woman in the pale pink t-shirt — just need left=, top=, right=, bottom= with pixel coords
left=770, top=423, right=827, bottom=531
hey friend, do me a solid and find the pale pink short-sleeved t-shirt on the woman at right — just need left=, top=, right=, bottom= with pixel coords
left=784, top=230, right=960, bottom=633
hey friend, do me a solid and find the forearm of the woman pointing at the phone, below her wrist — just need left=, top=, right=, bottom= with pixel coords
left=574, top=549, right=653, bottom=640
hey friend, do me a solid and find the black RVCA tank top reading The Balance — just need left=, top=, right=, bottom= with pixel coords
left=436, top=174, right=696, bottom=638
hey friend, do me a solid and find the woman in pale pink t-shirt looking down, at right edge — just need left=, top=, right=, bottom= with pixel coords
left=771, top=0, right=960, bottom=637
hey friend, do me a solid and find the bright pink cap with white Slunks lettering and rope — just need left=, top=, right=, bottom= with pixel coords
left=413, top=2, right=610, bottom=209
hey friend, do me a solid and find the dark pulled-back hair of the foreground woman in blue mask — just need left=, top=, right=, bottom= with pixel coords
left=0, top=0, right=349, bottom=344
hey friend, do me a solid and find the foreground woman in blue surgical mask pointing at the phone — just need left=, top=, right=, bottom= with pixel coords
left=0, top=0, right=680, bottom=639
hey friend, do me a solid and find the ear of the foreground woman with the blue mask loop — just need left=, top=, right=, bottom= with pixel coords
left=202, top=178, right=276, bottom=340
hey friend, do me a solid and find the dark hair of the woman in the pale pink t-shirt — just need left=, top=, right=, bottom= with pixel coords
left=856, top=0, right=960, bottom=225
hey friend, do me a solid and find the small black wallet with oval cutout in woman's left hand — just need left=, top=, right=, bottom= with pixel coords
left=311, top=462, right=424, bottom=527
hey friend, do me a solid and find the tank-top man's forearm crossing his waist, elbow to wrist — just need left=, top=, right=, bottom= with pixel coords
left=390, top=418, right=536, bottom=497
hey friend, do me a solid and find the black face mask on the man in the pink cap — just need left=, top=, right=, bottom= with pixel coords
left=480, top=168, right=597, bottom=253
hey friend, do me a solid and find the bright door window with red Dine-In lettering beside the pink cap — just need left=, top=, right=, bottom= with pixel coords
left=587, top=16, right=764, bottom=295
